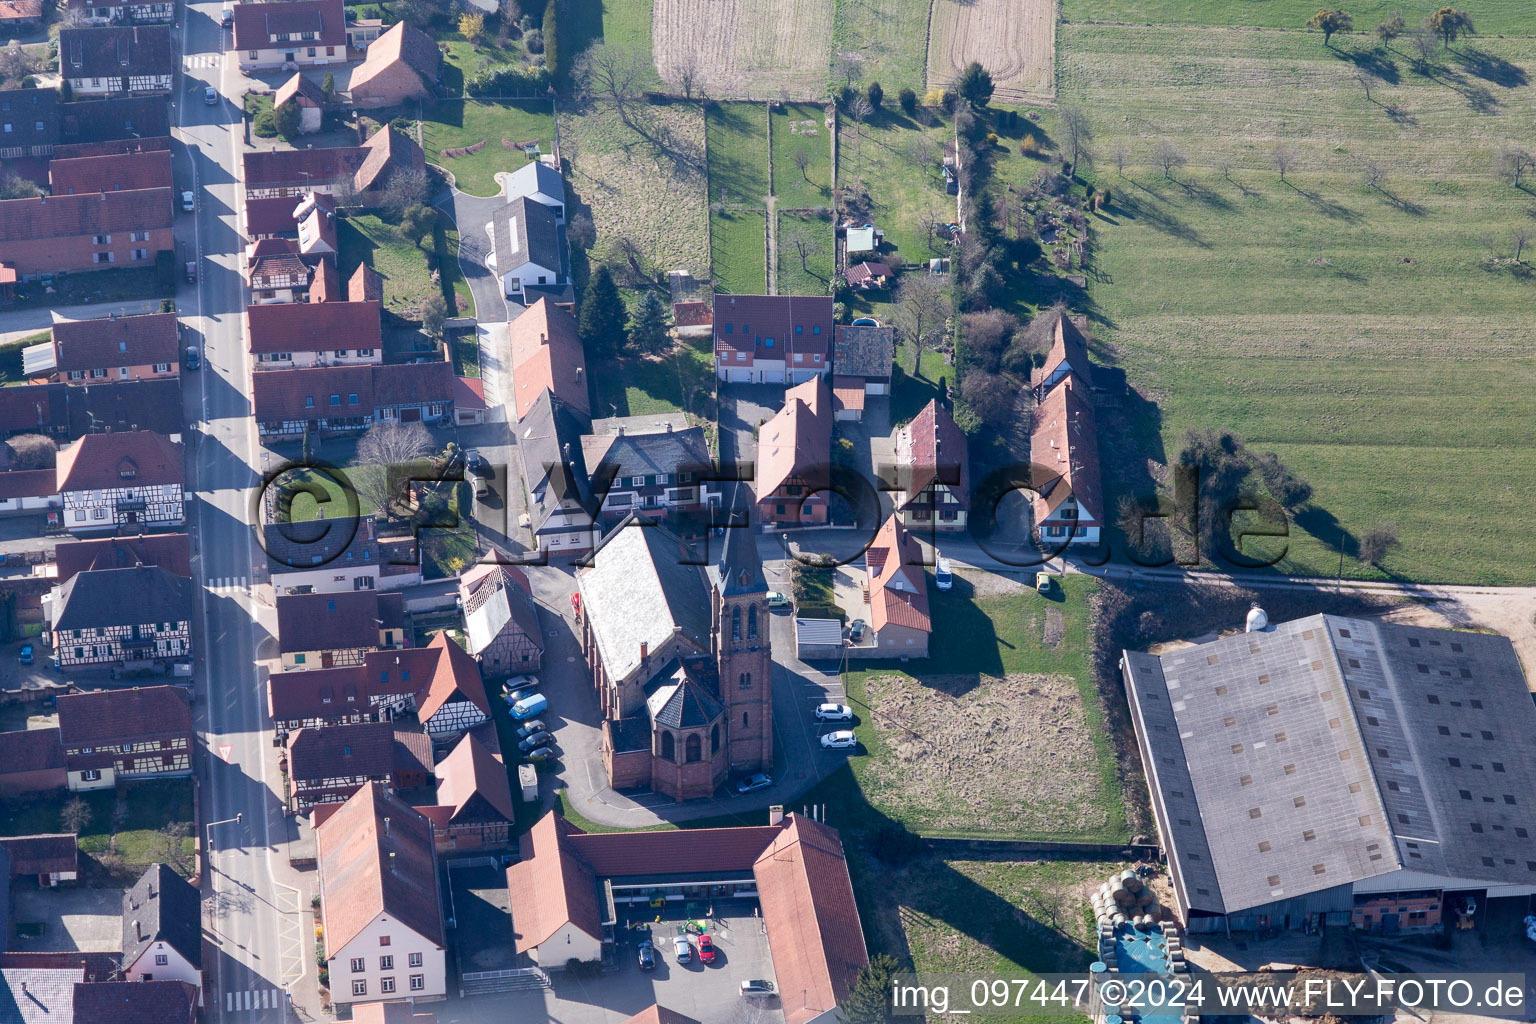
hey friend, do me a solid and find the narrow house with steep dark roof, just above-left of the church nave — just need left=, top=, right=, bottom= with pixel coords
left=515, top=388, right=594, bottom=554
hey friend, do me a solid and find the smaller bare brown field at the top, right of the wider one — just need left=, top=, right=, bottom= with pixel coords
left=928, top=0, right=1055, bottom=103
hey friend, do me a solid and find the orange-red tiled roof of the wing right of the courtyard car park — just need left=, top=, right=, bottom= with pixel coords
left=754, top=814, right=869, bottom=1024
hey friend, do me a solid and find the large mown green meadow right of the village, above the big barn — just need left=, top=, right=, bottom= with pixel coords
left=1061, top=25, right=1536, bottom=583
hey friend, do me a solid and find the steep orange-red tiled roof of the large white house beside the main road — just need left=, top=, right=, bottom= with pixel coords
left=315, top=783, right=444, bottom=958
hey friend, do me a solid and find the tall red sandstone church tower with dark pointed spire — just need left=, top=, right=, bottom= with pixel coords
left=710, top=525, right=773, bottom=772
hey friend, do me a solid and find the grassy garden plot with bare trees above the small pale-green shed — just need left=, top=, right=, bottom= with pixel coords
left=837, top=104, right=958, bottom=264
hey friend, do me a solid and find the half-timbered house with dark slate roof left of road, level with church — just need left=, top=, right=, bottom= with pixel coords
left=58, top=686, right=197, bottom=791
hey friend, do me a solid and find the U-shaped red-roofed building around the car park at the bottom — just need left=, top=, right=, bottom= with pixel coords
left=507, top=811, right=869, bottom=1024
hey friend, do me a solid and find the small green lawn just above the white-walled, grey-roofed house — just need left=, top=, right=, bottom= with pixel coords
left=421, top=100, right=554, bottom=195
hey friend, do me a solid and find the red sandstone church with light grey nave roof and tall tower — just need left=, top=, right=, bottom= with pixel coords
left=576, top=516, right=773, bottom=800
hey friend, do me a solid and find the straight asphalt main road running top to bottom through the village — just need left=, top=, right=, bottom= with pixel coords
left=172, top=2, right=299, bottom=1024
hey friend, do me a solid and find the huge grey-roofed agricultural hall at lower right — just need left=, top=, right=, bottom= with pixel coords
left=1121, top=616, right=1536, bottom=930
